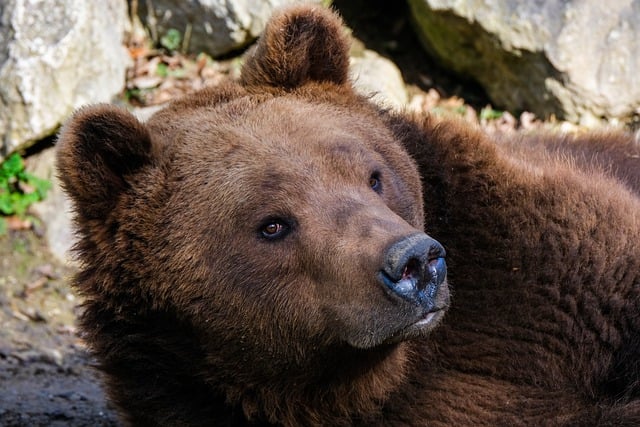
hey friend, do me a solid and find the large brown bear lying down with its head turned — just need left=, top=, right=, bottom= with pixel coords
left=57, top=4, right=640, bottom=426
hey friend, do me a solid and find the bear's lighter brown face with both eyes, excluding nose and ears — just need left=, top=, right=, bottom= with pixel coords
left=150, top=96, right=447, bottom=352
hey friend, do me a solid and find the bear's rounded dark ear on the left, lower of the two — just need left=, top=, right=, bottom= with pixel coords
left=56, top=105, right=152, bottom=219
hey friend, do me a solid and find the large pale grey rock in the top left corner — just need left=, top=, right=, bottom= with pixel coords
left=0, top=0, right=130, bottom=161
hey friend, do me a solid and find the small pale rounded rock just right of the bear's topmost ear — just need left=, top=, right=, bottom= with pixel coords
left=350, top=50, right=409, bottom=109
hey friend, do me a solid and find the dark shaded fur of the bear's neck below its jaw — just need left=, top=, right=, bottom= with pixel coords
left=81, top=300, right=413, bottom=426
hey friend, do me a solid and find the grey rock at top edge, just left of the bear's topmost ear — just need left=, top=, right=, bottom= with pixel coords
left=129, top=0, right=327, bottom=57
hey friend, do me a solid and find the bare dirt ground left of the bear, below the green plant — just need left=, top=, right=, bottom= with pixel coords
left=0, top=230, right=118, bottom=426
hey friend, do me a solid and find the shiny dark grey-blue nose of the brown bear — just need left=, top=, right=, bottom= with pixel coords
left=380, top=233, right=447, bottom=308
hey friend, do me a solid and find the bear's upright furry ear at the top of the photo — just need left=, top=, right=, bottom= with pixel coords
left=241, top=5, right=350, bottom=89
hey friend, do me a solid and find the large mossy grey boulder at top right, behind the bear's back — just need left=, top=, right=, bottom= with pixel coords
left=409, top=0, right=640, bottom=122
